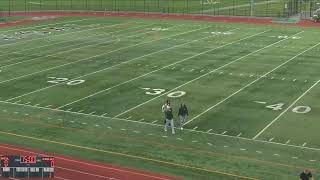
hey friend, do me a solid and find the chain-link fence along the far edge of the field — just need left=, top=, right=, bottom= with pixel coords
left=0, top=0, right=320, bottom=17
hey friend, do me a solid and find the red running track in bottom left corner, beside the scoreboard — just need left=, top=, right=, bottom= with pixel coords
left=0, top=145, right=181, bottom=180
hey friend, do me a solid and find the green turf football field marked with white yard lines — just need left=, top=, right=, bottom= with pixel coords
left=0, top=17, right=320, bottom=179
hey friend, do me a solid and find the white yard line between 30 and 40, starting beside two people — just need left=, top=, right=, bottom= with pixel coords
left=185, top=38, right=320, bottom=125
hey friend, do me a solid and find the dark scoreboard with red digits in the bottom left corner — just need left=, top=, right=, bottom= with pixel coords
left=0, top=156, right=55, bottom=178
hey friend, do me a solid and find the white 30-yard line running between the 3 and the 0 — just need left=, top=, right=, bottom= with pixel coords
left=115, top=31, right=303, bottom=118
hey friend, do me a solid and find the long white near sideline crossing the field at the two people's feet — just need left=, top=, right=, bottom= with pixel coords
left=0, top=101, right=320, bottom=151
